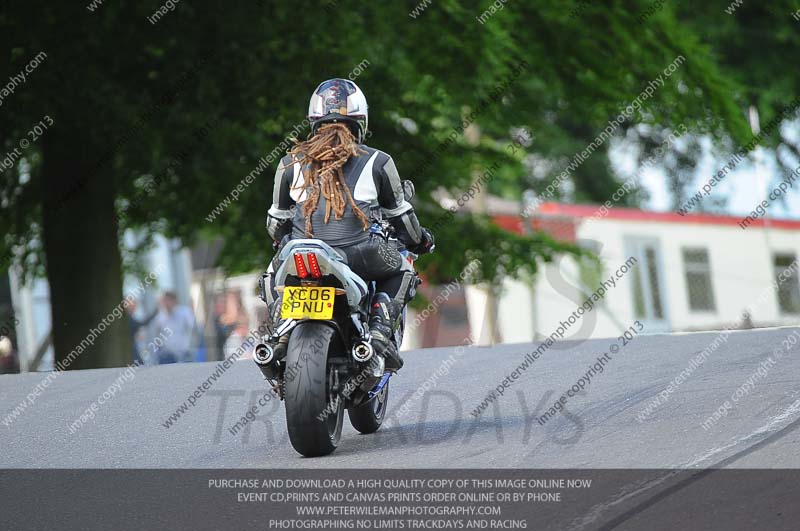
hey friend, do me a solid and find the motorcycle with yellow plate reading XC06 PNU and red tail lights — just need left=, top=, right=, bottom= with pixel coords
left=253, top=181, right=428, bottom=457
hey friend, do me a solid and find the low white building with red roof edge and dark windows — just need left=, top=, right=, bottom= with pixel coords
left=467, top=203, right=800, bottom=343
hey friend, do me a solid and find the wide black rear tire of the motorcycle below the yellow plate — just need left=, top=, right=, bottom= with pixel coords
left=285, top=321, right=344, bottom=457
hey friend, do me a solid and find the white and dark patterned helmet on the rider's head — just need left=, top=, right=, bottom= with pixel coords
left=308, top=78, right=369, bottom=142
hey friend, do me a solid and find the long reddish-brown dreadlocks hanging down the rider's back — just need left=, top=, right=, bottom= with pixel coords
left=289, top=123, right=369, bottom=238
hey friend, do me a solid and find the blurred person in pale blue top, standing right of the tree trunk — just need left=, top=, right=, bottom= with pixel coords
left=153, top=291, right=195, bottom=364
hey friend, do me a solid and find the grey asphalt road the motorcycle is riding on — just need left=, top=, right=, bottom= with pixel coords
left=0, top=328, right=800, bottom=468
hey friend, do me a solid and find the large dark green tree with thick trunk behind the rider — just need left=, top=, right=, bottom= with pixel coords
left=0, top=0, right=756, bottom=368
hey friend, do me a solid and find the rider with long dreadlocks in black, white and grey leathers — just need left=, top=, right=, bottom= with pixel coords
left=267, top=79, right=434, bottom=370
